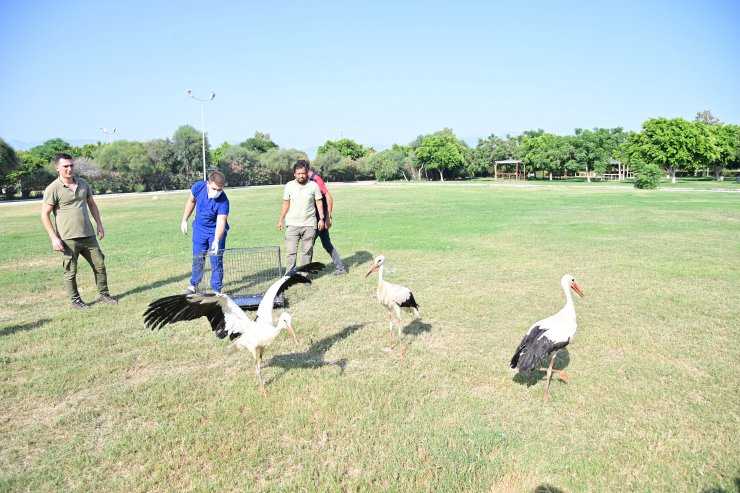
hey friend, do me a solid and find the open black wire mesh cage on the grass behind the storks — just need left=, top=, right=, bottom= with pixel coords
left=193, top=246, right=285, bottom=308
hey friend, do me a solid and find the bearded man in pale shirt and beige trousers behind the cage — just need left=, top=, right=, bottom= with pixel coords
left=278, top=159, right=326, bottom=272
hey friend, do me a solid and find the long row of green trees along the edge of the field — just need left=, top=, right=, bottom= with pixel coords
left=0, top=111, right=740, bottom=198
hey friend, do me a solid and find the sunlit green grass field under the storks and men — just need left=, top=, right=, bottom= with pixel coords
left=0, top=182, right=740, bottom=493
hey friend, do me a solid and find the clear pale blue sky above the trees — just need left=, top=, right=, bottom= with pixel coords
left=0, top=0, right=740, bottom=153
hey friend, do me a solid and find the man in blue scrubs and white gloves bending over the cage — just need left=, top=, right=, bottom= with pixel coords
left=180, top=171, right=229, bottom=294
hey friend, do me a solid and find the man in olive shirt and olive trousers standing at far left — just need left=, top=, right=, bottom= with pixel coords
left=41, top=153, right=118, bottom=310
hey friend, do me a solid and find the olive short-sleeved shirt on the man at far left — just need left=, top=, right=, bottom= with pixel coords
left=43, top=178, right=95, bottom=240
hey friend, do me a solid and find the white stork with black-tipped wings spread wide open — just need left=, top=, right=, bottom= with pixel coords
left=144, top=262, right=324, bottom=395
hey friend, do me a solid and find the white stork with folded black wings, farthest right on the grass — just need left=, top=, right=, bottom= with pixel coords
left=509, top=274, right=583, bottom=400
